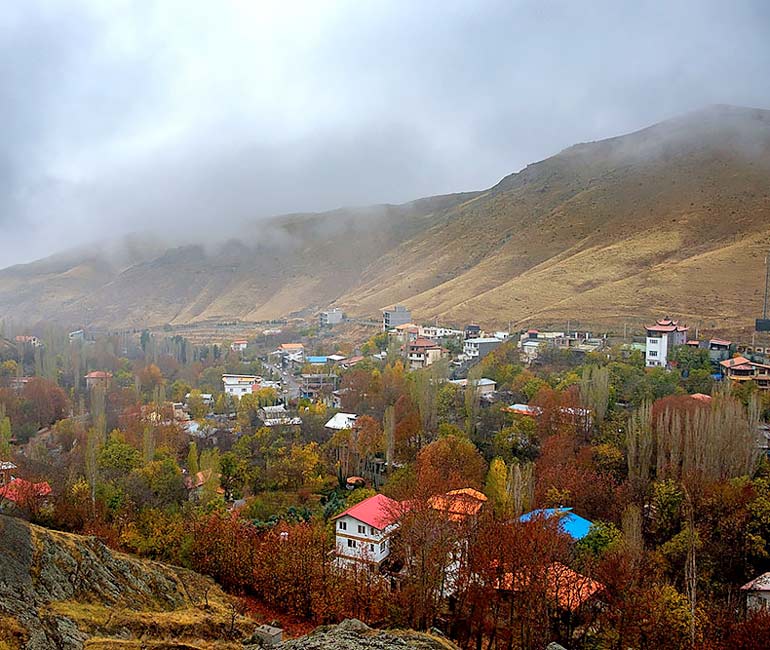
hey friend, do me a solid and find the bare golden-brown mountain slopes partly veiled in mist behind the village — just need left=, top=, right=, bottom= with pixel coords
left=0, top=106, right=770, bottom=334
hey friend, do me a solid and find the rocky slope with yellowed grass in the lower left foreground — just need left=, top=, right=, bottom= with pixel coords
left=0, top=515, right=255, bottom=650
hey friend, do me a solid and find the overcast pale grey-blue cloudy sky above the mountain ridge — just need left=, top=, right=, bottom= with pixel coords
left=0, top=0, right=770, bottom=268
